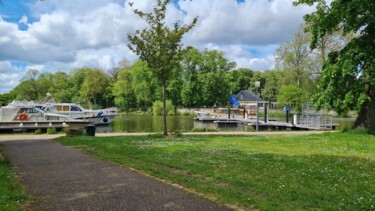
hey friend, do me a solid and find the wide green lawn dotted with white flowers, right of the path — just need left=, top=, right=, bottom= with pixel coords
left=59, top=132, right=375, bottom=210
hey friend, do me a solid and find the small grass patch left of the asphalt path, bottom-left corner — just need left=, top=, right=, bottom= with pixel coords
left=0, top=152, right=26, bottom=210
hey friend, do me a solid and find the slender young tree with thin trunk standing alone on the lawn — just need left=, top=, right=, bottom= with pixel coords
left=128, top=0, right=197, bottom=135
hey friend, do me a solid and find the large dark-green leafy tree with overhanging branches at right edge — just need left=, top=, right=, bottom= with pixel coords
left=294, top=0, right=375, bottom=132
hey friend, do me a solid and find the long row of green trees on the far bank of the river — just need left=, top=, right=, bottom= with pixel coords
left=0, top=48, right=318, bottom=111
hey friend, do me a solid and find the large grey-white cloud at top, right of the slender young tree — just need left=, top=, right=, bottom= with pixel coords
left=179, top=0, right=310, bottom=45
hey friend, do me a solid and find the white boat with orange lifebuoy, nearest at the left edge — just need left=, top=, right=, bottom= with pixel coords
left=0, top=101, right=89, bottom=130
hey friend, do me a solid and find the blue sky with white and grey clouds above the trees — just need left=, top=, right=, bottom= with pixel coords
left=0, top=0, right=313, bottom=93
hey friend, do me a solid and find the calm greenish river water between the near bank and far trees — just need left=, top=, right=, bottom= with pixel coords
left=97, top=115, right=355, bottom=133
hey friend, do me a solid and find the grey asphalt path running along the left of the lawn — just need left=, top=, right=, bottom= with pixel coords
left=1, top=139, right=231, bottom=210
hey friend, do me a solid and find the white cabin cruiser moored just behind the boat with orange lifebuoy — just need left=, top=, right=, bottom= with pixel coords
left=37, top=102, right=117, bottom=125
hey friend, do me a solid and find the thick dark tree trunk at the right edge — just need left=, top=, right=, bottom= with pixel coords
left=353, top=86, right=375, bottom=133
